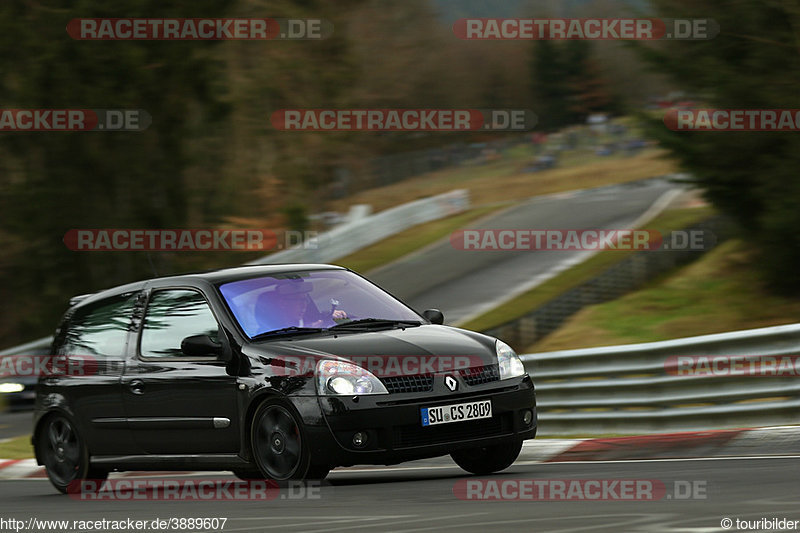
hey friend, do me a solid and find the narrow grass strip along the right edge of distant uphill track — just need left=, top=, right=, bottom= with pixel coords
left=459, top=207, right=713, bottom=331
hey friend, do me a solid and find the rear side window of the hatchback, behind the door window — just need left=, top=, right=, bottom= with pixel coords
left=56, top=292, right=138, bottom=358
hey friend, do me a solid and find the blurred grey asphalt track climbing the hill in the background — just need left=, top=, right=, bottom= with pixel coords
left=369, top=179, right=678, bottom=324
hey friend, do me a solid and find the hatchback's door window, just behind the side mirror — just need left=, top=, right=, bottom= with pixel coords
left=139, top=289, right=219, bottom=357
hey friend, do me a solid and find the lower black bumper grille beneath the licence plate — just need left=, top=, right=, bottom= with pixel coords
left=392, top=413, right=513, bottom=449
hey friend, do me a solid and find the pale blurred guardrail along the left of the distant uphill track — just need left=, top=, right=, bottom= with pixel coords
left=248, top=189, right=470, bottom=265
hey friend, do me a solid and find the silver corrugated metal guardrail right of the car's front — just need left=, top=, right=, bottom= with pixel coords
left=522, top=324, right=800, bottom=435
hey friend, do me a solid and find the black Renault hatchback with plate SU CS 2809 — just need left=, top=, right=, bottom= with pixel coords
left=33, top=265, right=537, bottom=492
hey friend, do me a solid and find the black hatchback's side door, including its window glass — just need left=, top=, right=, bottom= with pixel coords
left=122, top=286, right=239, bottom=454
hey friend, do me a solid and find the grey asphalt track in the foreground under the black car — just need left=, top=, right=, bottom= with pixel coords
left=0, top=457, right=800, bottom=533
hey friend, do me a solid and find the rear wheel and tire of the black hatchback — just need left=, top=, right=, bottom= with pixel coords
left=37, top=413, right=108, bottom=494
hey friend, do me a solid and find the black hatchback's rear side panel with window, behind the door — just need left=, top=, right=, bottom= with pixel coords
left=51, top=291, right=142, bottom=455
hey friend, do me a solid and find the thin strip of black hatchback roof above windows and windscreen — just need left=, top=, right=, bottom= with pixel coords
left=70, top=263, right=346, bottom=309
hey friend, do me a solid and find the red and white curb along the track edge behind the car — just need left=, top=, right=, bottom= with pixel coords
left=0, top=426, right=800, bottom=479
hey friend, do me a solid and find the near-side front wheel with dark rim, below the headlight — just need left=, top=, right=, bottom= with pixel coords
left=248, top=400, right=330, bottom=482
